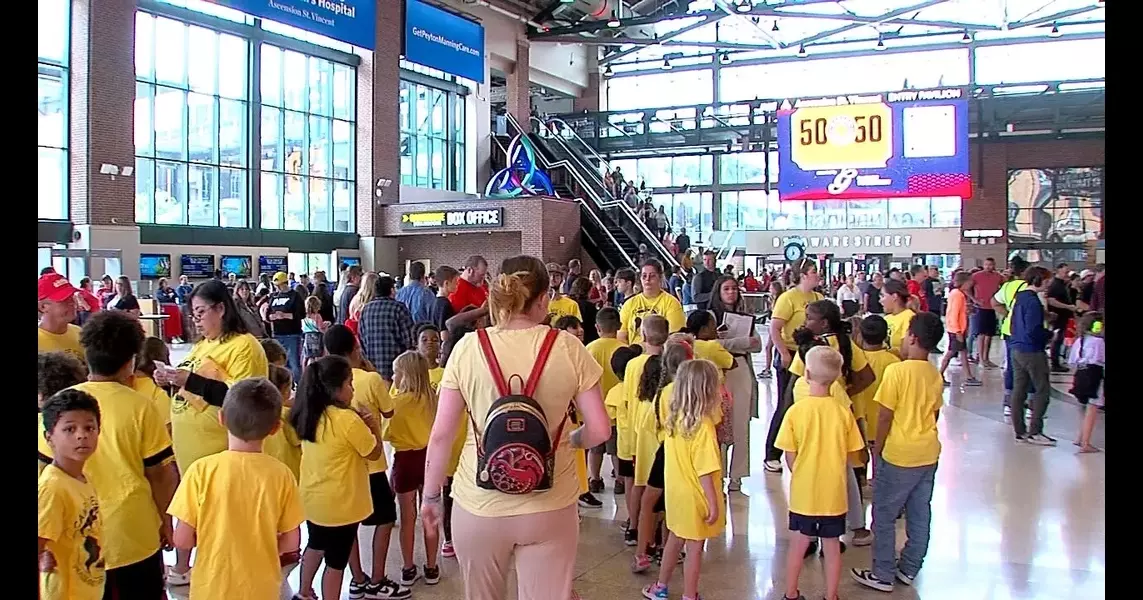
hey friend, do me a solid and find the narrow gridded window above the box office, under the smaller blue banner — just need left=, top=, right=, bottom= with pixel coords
left=399, top=78, right=465, bottom=191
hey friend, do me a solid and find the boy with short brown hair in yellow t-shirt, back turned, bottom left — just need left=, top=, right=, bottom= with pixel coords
left=168, top=378, right=304, bottom=598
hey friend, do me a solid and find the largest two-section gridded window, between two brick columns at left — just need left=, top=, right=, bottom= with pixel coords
left=135, top=5, right=357, bottom=232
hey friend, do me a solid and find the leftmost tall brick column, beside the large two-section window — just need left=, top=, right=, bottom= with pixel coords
left=69, top=0, right=135, bottom=226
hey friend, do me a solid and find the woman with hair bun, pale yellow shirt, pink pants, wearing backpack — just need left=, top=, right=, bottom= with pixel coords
left=421, top=256, right=612, bottom=600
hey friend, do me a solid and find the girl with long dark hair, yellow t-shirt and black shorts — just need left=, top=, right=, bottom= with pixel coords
left=289, top=357, right=384, bottom=598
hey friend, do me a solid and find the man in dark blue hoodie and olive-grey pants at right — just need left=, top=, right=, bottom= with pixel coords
left=1008, top=266, right=1056, bottom=446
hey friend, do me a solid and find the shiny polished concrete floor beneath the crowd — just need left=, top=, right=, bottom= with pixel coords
left=167, top=340, right=1105, bottom=600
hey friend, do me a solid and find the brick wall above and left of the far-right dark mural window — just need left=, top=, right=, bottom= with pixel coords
left=960, top=138, right=1104, bottom=266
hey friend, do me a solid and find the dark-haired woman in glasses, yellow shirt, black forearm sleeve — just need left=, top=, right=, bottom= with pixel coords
left=154, top=279, right=270, bottom=585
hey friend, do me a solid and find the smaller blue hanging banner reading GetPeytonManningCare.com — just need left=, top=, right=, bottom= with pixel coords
left=405, top=0, right=485, bottom=83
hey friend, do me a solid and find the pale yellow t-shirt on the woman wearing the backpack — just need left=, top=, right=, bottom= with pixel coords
left=440, top=326, right=602, bottom=517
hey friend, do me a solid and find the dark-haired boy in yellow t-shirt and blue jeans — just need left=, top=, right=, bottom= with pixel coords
left=850, top=312, right=944, bottom=592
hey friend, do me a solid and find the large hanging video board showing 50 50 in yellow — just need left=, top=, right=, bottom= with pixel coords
left=777, top=88, right=973, bottom=200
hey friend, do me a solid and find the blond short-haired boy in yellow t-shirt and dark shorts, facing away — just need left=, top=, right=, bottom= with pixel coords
left=774, top=346, right=859, bottom=600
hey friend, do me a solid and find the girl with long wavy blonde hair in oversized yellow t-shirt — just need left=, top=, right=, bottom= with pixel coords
left=642, top=358, right=726, bottom=599
